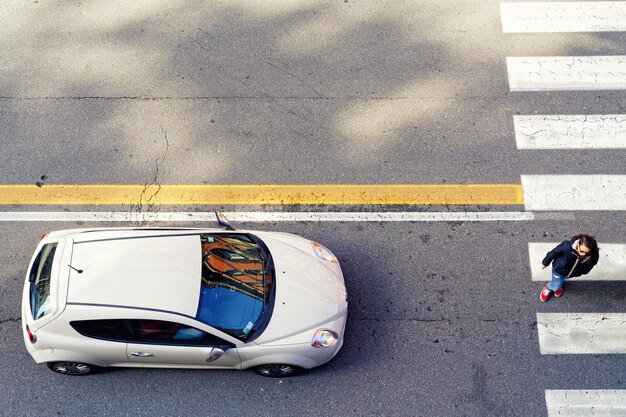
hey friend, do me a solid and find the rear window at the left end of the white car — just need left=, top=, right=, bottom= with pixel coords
left=28, top=243, right=57, bottom=320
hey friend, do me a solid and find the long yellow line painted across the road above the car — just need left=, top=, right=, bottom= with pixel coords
left=0, top=184, right=524, bottom=205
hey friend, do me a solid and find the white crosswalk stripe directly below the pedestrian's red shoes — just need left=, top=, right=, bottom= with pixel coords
left=537, top=313, right=626, bottom=355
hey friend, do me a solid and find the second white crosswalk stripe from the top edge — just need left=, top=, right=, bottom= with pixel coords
left=506, top=56, right=626, bottom=91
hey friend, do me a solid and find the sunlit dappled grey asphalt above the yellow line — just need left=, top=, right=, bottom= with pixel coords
left=0, top=0, right=624, bottom=184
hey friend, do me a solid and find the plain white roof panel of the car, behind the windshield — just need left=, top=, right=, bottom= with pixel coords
left=67, top=229, right=201, bottom=317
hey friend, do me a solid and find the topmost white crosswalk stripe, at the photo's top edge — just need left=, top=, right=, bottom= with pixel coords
left=500, top=1, right=626, bottom=33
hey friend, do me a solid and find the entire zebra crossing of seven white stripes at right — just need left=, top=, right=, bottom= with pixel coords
left=500, top=1, right=626, bottom=416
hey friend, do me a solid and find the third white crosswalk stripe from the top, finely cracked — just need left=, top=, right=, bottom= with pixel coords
left=513, top=114, right=626, bottom=149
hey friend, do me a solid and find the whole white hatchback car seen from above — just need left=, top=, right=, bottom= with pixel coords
left=22, top=213, right=348, bottom=377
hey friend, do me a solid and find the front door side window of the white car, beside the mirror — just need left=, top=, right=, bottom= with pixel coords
left=128, top=320, right=232, bottom=346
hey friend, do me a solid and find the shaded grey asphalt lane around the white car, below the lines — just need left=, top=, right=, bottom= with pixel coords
left=0, top=218, right=626, bottom=416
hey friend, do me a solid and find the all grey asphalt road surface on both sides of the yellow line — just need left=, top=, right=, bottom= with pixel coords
left=0, top=0, right=626, bottom=416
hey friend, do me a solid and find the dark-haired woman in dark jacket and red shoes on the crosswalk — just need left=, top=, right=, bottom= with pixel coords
left=539, top=235, right=600, bottom=302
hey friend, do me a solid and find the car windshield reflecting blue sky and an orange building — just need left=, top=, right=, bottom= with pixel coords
left=196, top=233, right=274, bottom=340
